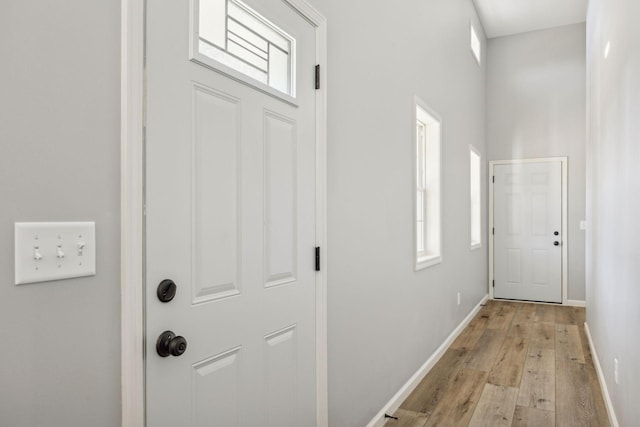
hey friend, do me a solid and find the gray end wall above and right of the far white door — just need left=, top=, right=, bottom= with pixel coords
left=487, top=24, right=586, bottom=301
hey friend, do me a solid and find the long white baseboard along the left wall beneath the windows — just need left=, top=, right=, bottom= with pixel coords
left=367, top=295, right=489, bottom=427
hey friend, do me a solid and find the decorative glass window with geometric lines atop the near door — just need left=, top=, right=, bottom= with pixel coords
left=191, top=0, right=296, bottom=98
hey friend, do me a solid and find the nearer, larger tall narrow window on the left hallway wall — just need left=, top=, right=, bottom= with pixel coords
left=414, top=98, right=442, bottom=270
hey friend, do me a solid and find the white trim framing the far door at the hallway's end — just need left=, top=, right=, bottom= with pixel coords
left=488, top=157, right=569, bottom=305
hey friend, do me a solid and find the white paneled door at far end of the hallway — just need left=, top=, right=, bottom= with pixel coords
left=493, top=161, right=563, bottom=303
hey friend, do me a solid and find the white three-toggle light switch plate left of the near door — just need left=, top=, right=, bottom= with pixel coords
left=15, top=222, right=96, bottom=285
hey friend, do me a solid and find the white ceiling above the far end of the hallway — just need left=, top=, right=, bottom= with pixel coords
left=473, top=0, right=588, bottom=38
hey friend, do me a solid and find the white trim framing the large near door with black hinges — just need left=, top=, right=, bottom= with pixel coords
left=120, top=0, right=328, bottom=427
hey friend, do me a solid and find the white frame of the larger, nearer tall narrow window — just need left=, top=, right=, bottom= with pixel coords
left=411, top=96, right=443, bottom=271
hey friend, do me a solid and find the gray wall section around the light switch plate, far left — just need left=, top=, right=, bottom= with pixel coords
left=0, top=0, right=120, bottom=427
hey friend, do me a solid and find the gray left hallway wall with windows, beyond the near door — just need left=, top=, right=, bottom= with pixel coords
left=313, top=0, right=487, bottom=427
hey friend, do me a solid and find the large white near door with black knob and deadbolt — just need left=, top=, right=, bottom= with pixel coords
left=145, top=0, right=316, bottom=427
